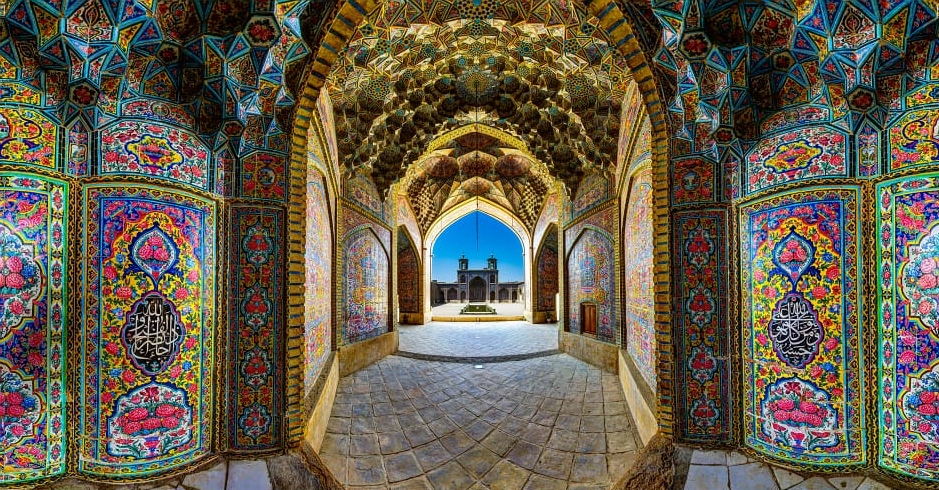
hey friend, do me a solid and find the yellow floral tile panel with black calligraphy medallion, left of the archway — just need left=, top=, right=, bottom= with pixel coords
left=76, top=183, right=216, bottom=476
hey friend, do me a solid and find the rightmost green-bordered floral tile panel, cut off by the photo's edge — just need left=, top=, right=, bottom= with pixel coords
left=877, top=173, right=939, bottom=482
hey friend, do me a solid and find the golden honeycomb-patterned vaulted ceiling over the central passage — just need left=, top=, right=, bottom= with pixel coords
left=326, top=0, right=635, bottom=226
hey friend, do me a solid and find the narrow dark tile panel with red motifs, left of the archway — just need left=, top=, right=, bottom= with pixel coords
left=228, top=205, right=284, bottom=450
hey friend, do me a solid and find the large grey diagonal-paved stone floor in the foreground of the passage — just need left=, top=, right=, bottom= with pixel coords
left=320, top=354, right=639, bottom=490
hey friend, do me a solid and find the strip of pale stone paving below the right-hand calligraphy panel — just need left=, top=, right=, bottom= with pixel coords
left=684, top=450, right=891, bottom=490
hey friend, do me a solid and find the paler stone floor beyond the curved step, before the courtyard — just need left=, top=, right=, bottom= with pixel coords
left=398, top=321, right=558, bottom=357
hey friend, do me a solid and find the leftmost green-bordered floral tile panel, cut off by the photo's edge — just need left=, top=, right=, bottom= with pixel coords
left=0, top=172, right=68, bottom=485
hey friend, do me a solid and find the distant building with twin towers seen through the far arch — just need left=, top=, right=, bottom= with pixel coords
left=430, top=254, right=525, bottom=304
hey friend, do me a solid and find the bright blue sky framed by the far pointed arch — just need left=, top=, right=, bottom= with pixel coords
left=431, top=211, right=525, bottom=282
